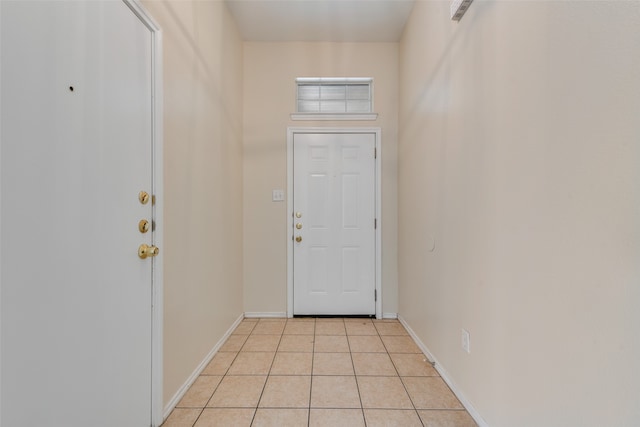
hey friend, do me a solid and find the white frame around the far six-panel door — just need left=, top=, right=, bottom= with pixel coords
left=286, top=127, right=382, bottom=319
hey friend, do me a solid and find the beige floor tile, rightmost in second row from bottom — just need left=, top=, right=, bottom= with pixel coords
left=402, top=377, right=464, bottom=409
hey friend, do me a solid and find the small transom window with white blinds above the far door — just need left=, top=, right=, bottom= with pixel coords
left=296, top=77, right=373, bottom=114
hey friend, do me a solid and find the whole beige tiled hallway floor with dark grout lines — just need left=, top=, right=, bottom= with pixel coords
left=163, top=318, right=476, bottom=427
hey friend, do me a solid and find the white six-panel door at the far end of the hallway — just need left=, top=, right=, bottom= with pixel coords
left=293, top=133, right=376, bottom=315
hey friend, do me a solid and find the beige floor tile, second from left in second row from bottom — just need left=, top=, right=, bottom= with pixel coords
left=207, top=375, right=267, bottom=408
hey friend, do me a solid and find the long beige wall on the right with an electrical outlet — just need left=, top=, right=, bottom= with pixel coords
left=398, top=1, right=640, bottom=427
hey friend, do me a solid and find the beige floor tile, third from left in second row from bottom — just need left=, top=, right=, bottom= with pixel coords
left=258, top=376, right=311, bottom=408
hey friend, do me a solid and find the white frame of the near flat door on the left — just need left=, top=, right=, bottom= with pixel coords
left=122, top=0, right=164, bottom=427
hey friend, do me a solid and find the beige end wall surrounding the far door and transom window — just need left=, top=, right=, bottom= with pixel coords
left=244, top=43, right=398, bottom=313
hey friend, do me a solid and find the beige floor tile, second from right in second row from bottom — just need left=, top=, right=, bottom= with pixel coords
left=358, top=377, right=413, bottom=409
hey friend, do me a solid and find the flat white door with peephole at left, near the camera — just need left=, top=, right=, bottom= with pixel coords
left=0, top=1, right=156, bottom=427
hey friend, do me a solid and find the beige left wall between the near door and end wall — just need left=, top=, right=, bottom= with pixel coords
left=144, top=0, right=243, bottom=405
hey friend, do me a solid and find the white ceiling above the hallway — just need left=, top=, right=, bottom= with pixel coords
left=225, top=0, right=414, bottom=42
